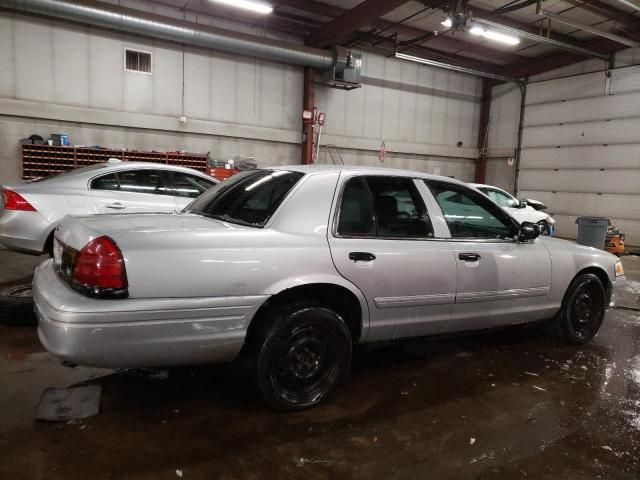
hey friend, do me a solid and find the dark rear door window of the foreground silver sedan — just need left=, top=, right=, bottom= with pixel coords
left=337, top=176, right=433, bottom=238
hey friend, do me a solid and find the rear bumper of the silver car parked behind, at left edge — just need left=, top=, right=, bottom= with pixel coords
left=0, top=210, right=51, bottom=255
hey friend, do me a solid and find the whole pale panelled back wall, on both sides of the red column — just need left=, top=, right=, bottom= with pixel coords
left=0, top=0, right=479, bottom=182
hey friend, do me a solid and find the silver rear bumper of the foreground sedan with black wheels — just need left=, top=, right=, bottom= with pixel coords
left=33, top=260, right=268, bottom=368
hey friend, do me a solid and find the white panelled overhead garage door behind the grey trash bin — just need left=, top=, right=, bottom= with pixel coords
left=518, top=67, right=640, bottom=246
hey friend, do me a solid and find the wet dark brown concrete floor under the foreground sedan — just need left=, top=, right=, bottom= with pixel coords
left=0, top=251, right=640, bottom=480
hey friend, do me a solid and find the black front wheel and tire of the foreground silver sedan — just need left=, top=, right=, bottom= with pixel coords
left=550, top=273, right=607, bottom=344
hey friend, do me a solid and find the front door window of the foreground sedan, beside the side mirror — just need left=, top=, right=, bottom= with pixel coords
left=425, top=180, right=516, bottom=239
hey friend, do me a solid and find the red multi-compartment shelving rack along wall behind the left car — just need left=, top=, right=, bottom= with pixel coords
left=22, top=145, right=208, bottom=180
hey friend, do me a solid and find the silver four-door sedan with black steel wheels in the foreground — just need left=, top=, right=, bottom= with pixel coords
left=34, top=166, right=625, bottom=410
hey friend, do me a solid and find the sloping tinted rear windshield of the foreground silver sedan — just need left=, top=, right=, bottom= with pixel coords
left=185, top=170, right=304, bottom=227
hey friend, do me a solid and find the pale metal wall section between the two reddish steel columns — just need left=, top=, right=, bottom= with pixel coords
left=316, top=53, right=480, bottom=180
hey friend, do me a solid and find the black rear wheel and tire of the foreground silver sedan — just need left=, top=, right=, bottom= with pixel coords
left=254, top=303, right=352, bottom=412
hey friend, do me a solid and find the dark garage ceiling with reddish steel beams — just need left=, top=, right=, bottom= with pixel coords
left=149, top=0, right=640, bottom=77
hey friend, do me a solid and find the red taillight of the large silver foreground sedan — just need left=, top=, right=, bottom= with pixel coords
left=71, top=237, right=128, bottom=297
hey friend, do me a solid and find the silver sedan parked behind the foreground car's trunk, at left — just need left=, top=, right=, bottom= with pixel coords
left=0, top=159, right=217, bottom=255
